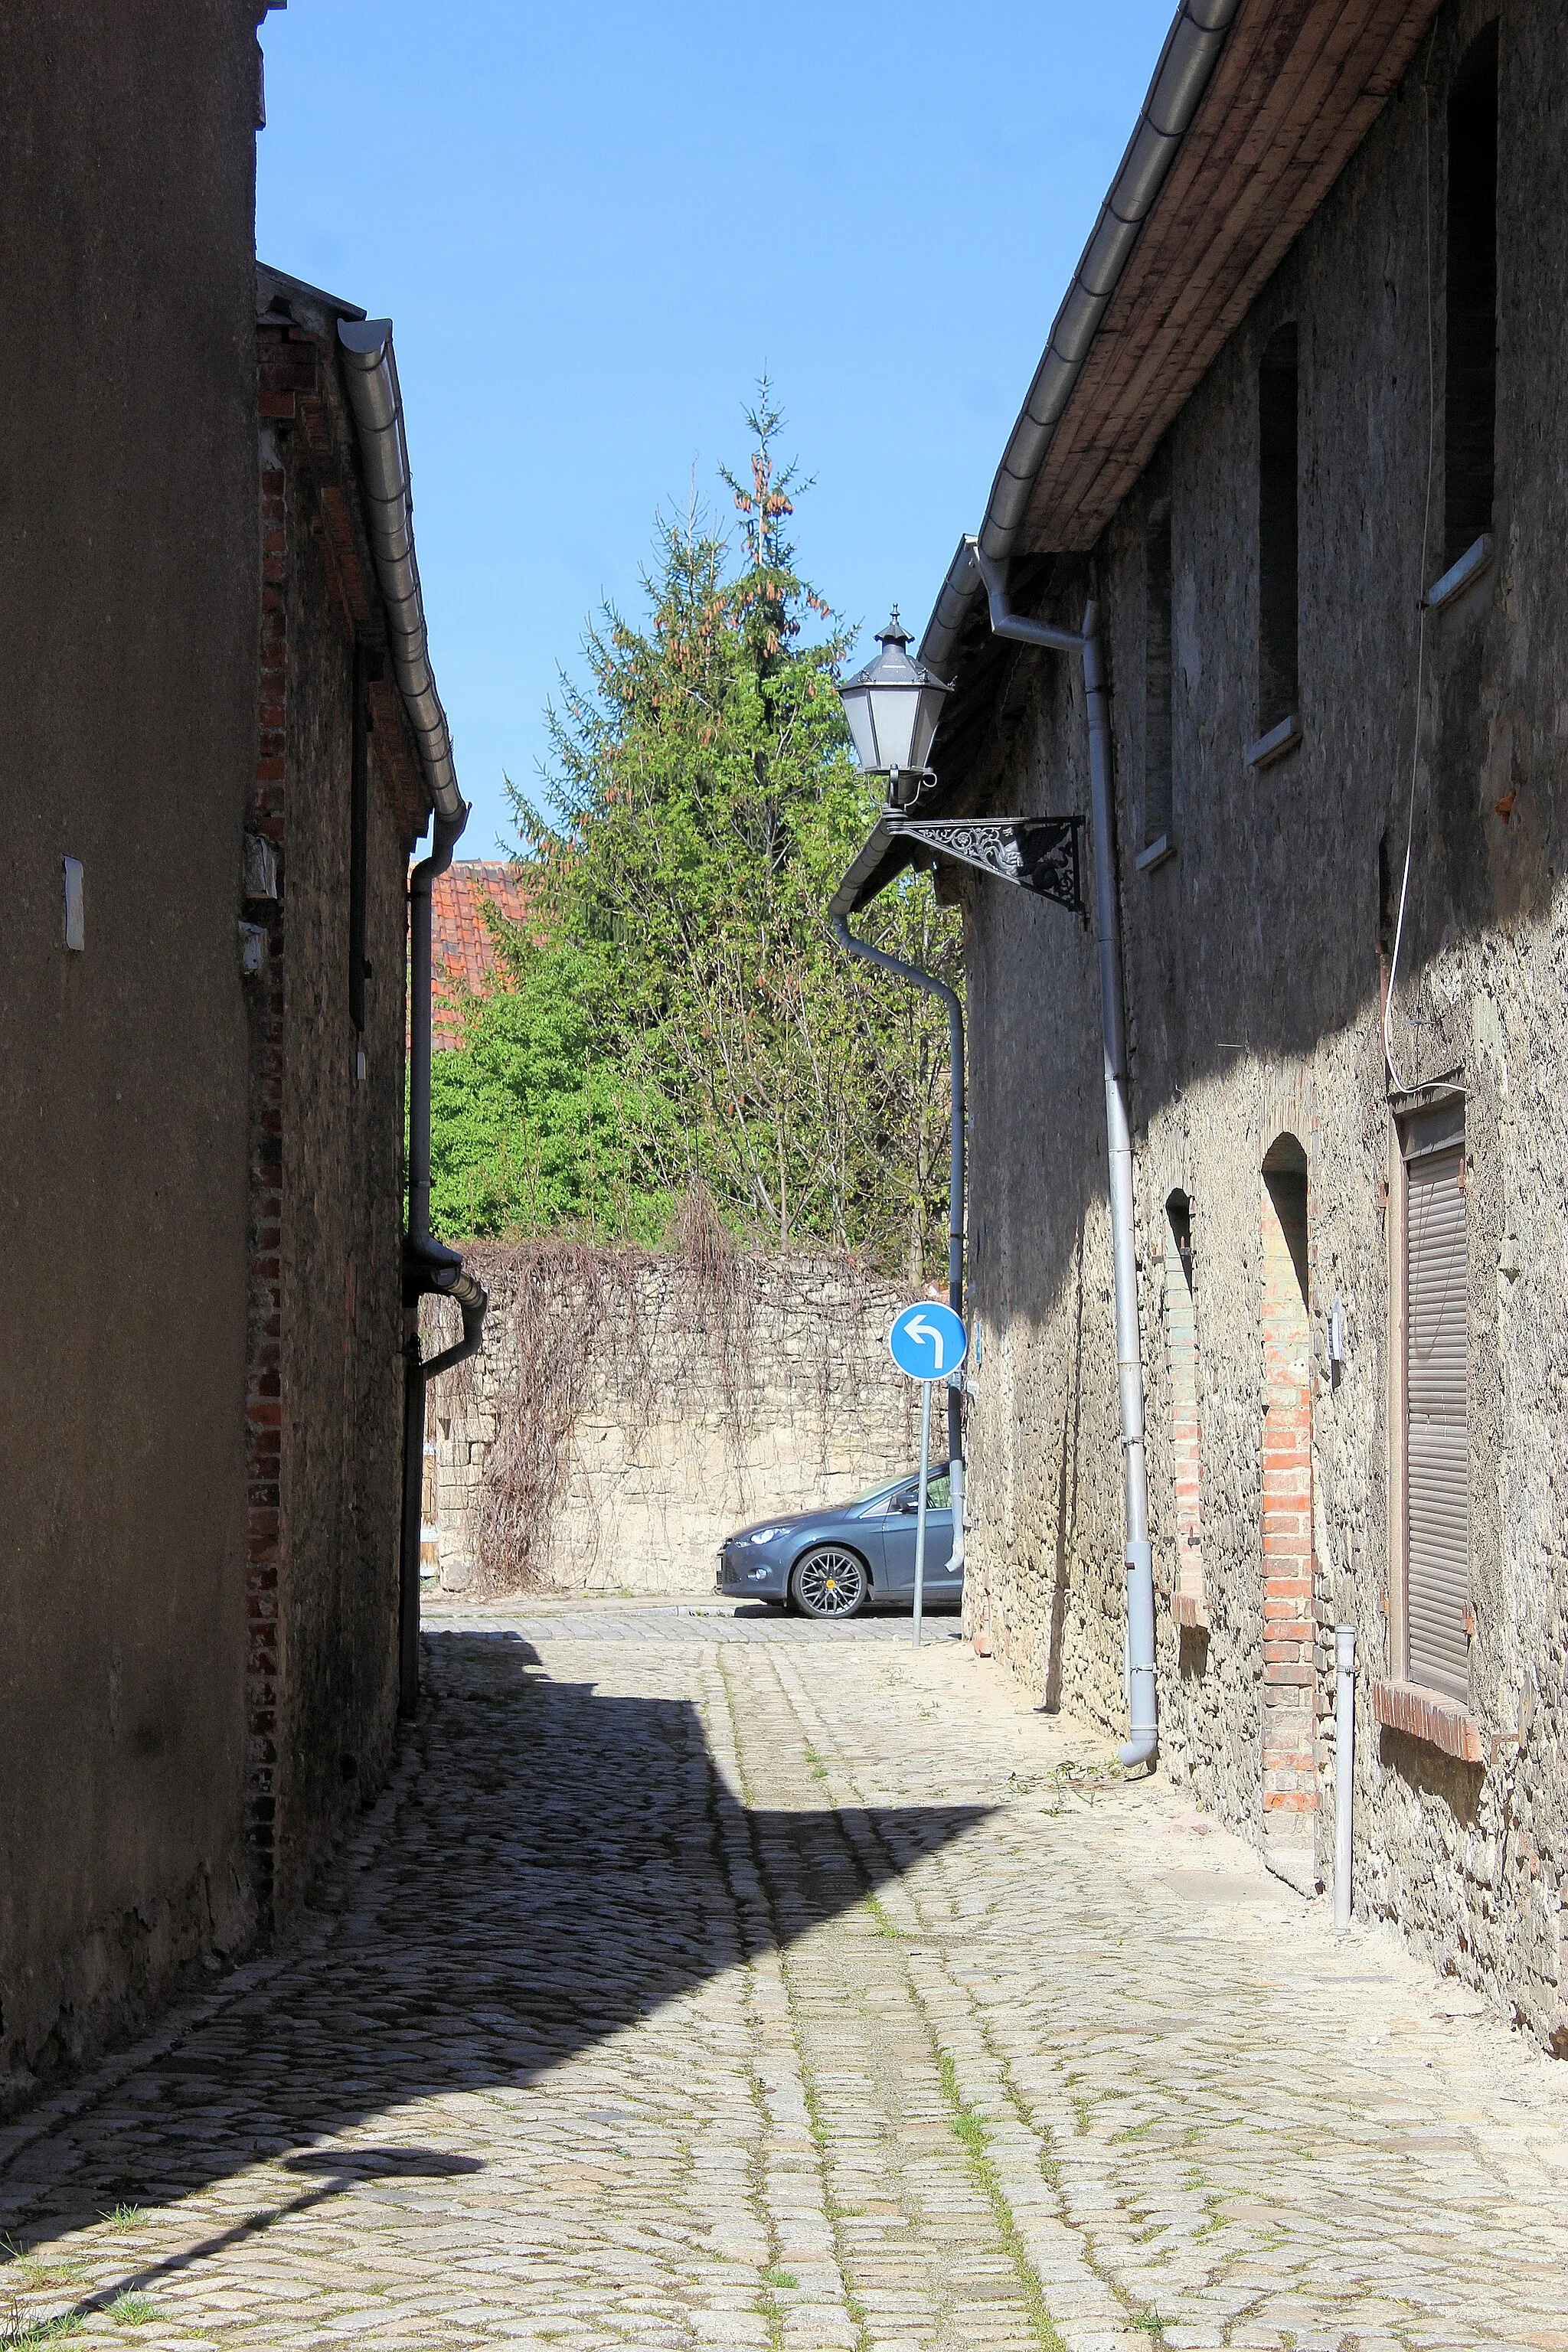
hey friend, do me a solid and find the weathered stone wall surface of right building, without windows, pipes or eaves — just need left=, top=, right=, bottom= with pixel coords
left=964, top=0, right=1568, bottom=2039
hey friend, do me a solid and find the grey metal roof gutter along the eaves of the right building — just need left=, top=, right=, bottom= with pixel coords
left=920, top=0, right=1241, bottom=678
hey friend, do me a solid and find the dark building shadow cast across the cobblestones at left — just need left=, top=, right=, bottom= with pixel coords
left=0, top=1630, right=990, bottom=2267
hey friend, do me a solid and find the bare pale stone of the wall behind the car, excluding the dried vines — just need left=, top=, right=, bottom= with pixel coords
left=430, top=1246, right=921, bottom=1595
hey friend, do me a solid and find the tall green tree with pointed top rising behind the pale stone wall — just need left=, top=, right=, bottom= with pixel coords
left=437, top=384, right=959, bottom=1277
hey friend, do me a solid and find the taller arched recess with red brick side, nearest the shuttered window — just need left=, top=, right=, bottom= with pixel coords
left=1263, top=1134, right=1316, bottom=1867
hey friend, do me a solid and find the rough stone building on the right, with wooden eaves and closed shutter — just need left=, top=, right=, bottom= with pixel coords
left=841, top=0, right=1568, bottom=2049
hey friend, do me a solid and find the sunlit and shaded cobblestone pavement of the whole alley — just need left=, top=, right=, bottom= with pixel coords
left=0, top=1606, right=1568, bottom=2352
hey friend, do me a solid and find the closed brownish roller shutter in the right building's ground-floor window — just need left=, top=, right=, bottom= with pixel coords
left=1406, top=1143, right=1469, bottom=1698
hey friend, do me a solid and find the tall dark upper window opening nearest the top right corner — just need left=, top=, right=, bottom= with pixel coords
left=1443, top=24, right=1498, bottom=567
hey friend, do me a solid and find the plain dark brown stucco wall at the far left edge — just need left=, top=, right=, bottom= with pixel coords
left=0, top=0, right=256, bottom=2096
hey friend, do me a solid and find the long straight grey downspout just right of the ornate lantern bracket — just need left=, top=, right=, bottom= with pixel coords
left=971, top=541, right=1159, bottom=1764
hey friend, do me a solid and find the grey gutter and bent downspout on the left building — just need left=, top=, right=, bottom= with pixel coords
left=338, top=318, right=489, bottom=1720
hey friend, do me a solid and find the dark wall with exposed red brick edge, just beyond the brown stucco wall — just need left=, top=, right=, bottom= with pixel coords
left=247, top=284, right=439, bottom=1926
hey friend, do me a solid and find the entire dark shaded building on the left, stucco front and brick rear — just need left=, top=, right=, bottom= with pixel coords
left=0, top=0, right=479, bottom=2105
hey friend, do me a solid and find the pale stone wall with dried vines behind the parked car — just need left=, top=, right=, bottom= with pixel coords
left=426, top=1242, right=920, bottom=1595
